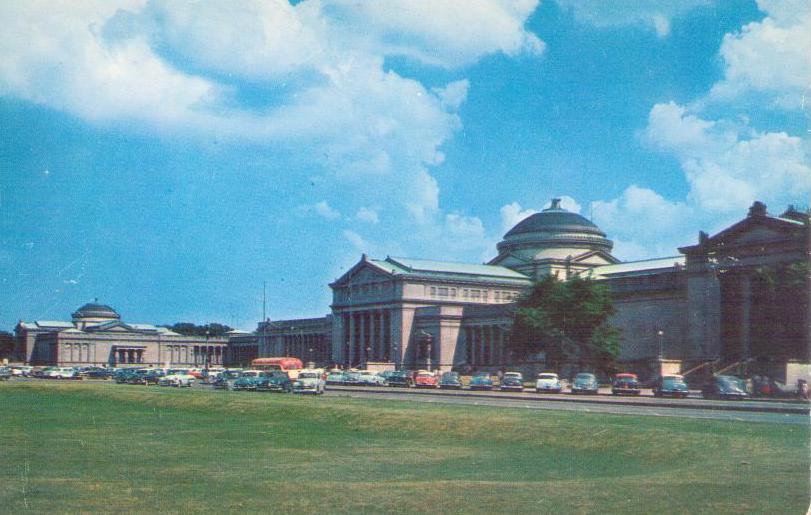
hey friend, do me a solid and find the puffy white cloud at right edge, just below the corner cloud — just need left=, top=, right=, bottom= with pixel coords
left=643, top=102, right=811, bottom=213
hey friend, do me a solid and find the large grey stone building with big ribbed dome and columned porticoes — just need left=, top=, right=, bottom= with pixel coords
left=255, top=200, right=811, bottom=377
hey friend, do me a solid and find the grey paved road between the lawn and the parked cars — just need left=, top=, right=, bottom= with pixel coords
left=327, top=388, right=809, bottom=425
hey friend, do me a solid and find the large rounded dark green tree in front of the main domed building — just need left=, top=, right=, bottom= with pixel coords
left=510, top=276, right=620, bottom=372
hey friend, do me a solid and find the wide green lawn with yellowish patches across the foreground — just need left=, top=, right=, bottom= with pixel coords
left=0, top=382, right=809, bottom=514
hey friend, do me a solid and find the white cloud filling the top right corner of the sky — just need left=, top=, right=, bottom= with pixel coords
left=708, top=0, right=811, bottom=109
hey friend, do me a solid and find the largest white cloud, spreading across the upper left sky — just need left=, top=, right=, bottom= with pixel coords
left=0, top=0, right=543, bottom=230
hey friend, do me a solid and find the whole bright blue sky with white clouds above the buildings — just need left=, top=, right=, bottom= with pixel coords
left=0, top=0, right=811, bottom=330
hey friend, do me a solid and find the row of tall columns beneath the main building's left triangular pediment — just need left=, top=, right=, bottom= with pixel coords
left=341, top=309, right=396, bottom=366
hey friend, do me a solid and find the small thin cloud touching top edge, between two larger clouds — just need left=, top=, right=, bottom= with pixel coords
left=557, top=0, right=712, bottom=38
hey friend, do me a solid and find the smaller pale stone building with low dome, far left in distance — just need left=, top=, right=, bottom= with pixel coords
left=15, top=303, right=228, bottom=366
